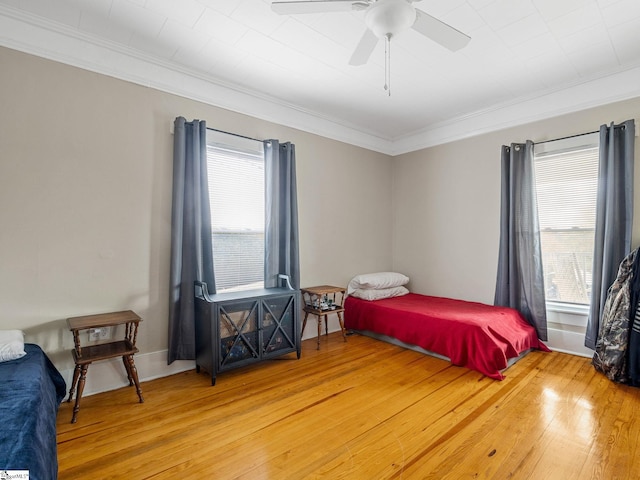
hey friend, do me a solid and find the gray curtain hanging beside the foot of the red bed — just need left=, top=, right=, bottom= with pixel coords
left=494, top=141, right=547, bottom=340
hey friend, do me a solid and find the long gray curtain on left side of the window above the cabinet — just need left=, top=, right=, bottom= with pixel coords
left=168, top=117, right=215, bottom=363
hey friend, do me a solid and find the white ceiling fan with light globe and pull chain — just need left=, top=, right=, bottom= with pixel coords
left=271, top=0, right=471, bottom=95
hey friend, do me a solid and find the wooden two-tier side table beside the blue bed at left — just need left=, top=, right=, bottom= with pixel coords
left=67, top=310, right=144, bottom=423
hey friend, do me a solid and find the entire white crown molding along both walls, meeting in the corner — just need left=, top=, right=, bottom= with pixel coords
left=0, top=5, right=640, bottom=156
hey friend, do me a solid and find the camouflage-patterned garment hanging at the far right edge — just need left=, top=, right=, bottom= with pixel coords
left=592, top=249, right=638, bottom=383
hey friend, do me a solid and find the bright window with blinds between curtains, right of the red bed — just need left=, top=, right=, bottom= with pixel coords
left=534, top=134, right=598, bottom=305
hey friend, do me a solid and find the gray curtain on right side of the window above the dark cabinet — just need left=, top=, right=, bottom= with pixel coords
left=264, top=140, right=300, bottom=289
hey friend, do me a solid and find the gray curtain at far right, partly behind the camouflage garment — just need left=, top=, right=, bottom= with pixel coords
left=584, top=120, right=635, bottom=349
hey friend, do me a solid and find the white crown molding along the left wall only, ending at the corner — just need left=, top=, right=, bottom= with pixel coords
left=0, top=5, right=391, bottom=154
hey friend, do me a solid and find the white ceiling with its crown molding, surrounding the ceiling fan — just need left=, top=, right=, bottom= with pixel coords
left=0, top=0, right=640, bottom=154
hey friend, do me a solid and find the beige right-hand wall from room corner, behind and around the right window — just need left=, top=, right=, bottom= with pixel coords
left=393, top=99, right=640, bottom=303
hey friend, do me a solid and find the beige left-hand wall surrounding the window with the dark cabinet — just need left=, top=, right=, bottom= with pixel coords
left=0, top=48, right=391, bottom=377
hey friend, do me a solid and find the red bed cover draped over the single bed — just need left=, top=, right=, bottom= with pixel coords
left=344, top=293, right=549, bottom=380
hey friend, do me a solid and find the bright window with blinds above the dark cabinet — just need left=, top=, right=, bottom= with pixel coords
left=207, top=130, right=265, bottom=292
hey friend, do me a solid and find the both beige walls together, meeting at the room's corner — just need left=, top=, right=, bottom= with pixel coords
left=0, top=44, right=640, bottom=382
